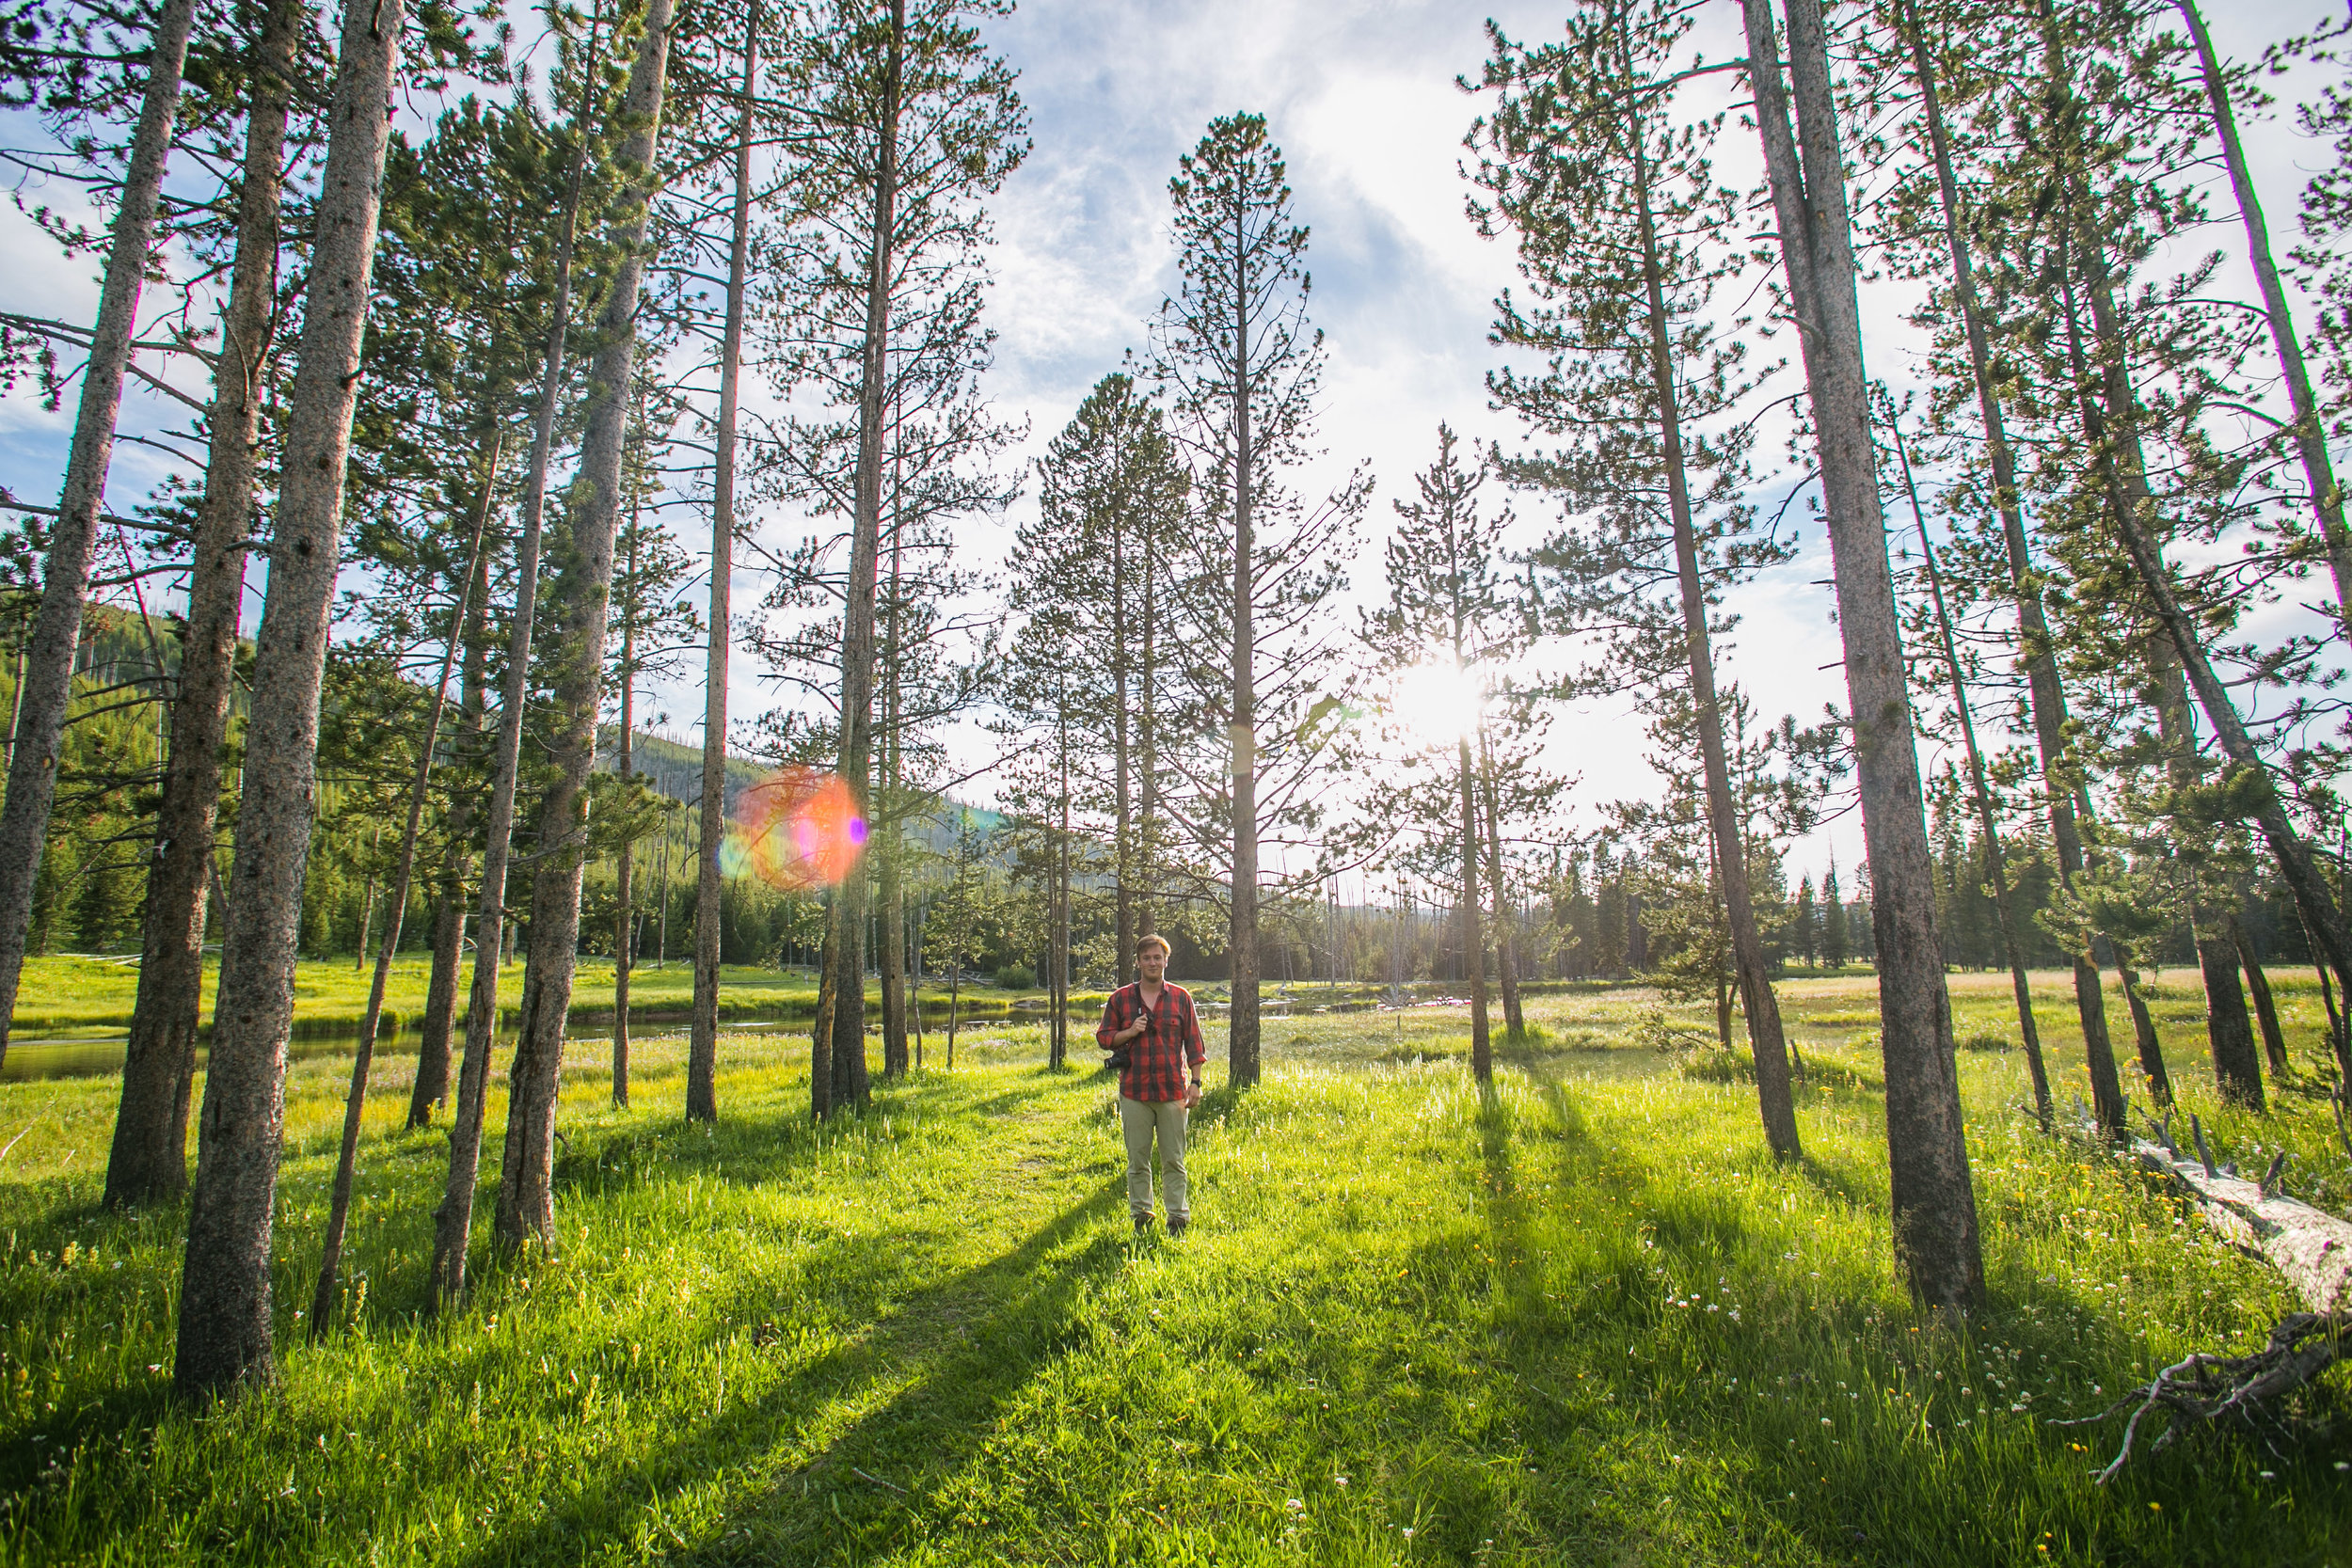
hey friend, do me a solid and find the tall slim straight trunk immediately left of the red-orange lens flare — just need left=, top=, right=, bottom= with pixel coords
left=687, top=15, right=760, bottom=1121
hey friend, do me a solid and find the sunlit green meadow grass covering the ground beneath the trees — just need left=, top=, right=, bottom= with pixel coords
left=0, top=975, right=2352, bottom=1568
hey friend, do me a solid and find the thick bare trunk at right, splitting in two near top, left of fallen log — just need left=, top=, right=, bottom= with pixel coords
left=1743, top=0, right=1985, bottom=1312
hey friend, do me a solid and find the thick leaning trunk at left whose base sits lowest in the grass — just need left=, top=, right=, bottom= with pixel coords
left=172, top=0, right=407, bottom=1403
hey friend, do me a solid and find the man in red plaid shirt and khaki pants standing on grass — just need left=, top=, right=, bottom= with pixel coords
left=1094, top=936, right=1209, bottom=1237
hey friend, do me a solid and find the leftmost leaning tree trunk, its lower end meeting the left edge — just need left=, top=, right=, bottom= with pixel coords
left=0, top=0, right=198, bottom=1071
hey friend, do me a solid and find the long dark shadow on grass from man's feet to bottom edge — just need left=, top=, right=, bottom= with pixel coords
left=442, top=1180, right=1129, bottom=1568
